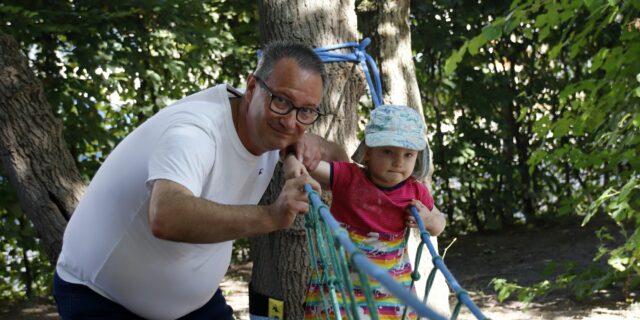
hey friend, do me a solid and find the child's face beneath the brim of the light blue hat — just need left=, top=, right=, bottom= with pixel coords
left=364, top=147, right=418, bottom=187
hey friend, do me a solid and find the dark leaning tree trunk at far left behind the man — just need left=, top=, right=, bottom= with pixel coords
left=0, top=32, right=85, bottom=262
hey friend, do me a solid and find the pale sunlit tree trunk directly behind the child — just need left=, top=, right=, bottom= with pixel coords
left=358, top=0, right=450, bottom=315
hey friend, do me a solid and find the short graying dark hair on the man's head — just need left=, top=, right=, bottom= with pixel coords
left=253, top=41, right=327, bottom=92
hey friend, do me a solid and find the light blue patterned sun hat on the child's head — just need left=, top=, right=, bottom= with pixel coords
left=364, top=105, right=427, bottom=150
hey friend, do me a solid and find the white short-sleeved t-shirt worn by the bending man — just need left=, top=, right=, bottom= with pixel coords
left=56, top=85, right=278, bottom=319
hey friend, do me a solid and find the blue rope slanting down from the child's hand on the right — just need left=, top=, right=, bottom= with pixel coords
left=411, top=206, right=487, bottom=319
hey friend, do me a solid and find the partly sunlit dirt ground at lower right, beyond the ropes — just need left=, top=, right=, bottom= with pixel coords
left=443, top=216, right=640, bottom=320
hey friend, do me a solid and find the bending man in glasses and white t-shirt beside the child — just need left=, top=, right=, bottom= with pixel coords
left=54, top=43, right=347, bottom=319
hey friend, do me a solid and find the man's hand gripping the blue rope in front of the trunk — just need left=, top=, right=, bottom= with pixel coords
left=269, top=175, right=321, bottom=230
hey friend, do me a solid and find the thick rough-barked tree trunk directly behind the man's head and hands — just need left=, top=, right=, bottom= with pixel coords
left=251, top=0, right=365, bottom=319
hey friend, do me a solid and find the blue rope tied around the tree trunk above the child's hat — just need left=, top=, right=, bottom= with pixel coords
left=314, top=38, right=383, bottom=108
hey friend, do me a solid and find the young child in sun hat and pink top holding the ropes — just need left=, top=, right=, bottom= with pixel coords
left=284, top=105, right=445, bottom=319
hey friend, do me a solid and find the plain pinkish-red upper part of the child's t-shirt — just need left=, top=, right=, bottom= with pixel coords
left=331, top=161, right=433, bottom=234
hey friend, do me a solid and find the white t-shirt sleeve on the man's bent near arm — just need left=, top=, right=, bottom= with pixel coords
left=147, top=122, right=216, bottom=196
